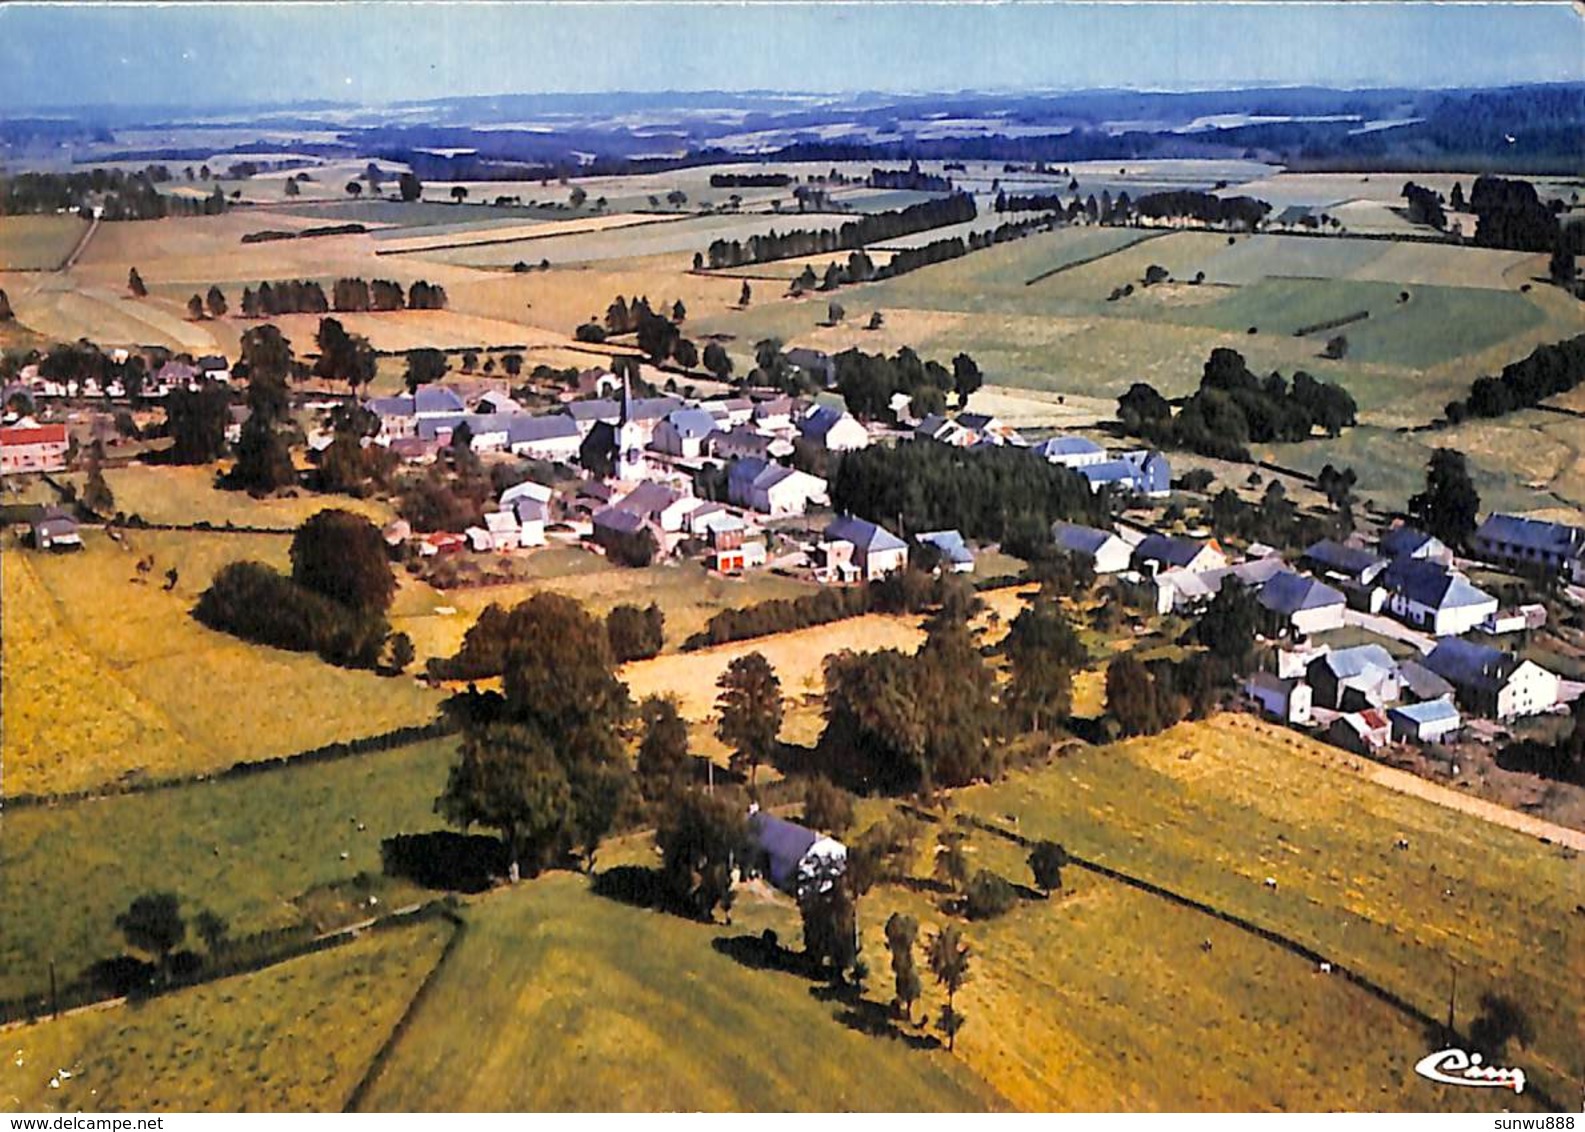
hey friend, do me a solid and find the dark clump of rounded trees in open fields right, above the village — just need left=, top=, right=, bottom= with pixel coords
left=1117, top=346, right=1357, bottom=461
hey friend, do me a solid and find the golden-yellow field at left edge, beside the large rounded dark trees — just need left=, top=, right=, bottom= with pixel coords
left=3, top=531, right=437, bottom=794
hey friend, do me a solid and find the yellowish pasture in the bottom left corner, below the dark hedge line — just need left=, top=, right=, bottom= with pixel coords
left=0, top=921, right=452, bottom=1113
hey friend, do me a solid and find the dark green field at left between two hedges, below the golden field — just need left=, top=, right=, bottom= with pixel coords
left=0, top=740, right=455, bottom=999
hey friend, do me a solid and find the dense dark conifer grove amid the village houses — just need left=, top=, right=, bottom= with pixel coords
left=831, top=442, right=1106, bottom=542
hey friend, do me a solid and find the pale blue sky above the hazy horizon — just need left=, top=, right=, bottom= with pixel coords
left=0, top=0, right=1585, bottom=110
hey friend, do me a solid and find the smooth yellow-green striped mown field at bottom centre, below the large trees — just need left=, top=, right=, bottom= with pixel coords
left=353, top=874, right=997, bottom=1111
